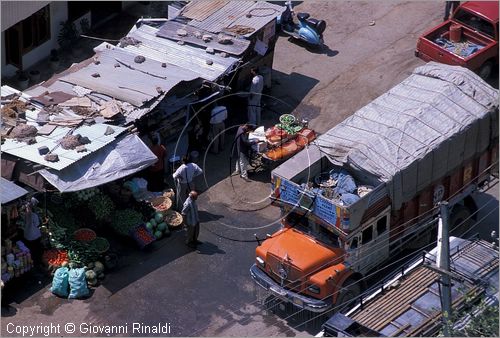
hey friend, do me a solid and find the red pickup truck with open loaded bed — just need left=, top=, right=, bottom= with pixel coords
left=415, top=1, right=498, bottom=79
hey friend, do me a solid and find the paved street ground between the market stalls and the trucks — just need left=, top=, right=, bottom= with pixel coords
left=1, top=1, right=498, bottom=336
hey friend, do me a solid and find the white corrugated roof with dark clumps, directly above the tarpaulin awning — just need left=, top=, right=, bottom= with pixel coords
left=2, top=124, right=126, bottom=170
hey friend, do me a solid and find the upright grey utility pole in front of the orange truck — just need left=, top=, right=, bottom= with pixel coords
left=436, top=202, right=451, bottom=337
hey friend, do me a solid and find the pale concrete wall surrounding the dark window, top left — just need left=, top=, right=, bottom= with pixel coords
left=2, top=1, right=68, bottom=77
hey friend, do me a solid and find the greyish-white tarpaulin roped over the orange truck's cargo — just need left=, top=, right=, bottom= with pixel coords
left=305, top=62, right=498, bottom=208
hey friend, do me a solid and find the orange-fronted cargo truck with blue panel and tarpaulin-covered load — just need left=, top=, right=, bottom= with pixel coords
left=250, top=62, right=498, bottom=312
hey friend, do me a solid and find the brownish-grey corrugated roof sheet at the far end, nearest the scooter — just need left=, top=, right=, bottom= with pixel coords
left=189, top=1, right=285, bottom=37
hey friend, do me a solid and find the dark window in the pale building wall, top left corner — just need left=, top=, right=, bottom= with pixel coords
left=5, top=5, right=50, bottom=68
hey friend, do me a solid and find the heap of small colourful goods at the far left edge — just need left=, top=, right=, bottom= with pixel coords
left=2, top=239, right=33, bottom=282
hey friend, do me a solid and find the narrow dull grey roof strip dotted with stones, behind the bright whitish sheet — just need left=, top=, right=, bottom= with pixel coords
left=157, top=21, right=250, bottom=55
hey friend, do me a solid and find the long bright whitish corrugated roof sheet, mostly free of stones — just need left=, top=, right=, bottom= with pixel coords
left=124, top=25, right=239, bottom=81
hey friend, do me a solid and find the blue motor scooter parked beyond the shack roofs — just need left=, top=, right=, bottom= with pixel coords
left=278, top=1, right=326, bottom=46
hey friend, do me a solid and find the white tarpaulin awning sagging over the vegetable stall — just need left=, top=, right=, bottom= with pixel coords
left=40, top=135, right=157, bottom=192
